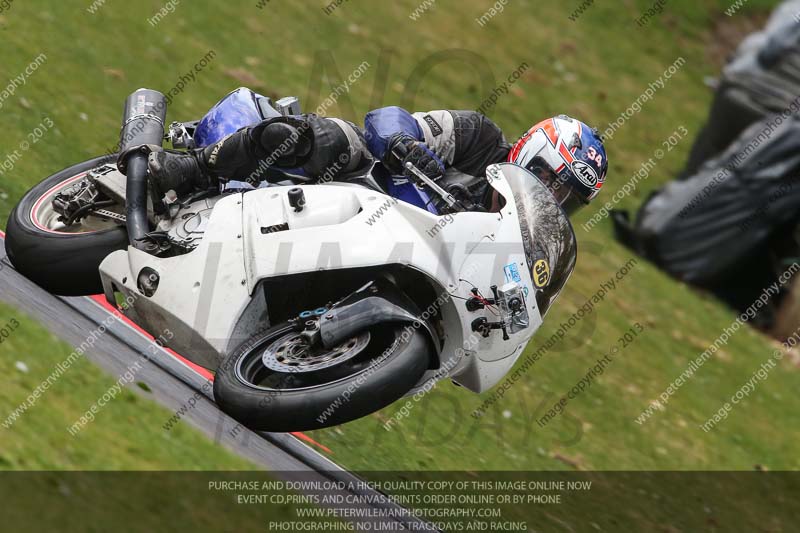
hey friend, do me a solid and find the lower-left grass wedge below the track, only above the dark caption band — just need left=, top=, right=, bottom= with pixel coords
left=0, top=303, right=254, bottom=470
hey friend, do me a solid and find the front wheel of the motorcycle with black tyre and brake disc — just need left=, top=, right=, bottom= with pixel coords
left=214, top=323, right=430, bottom=432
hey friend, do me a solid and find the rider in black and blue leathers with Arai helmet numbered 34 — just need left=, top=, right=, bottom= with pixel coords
left=148, top=107, right=608, bottom=214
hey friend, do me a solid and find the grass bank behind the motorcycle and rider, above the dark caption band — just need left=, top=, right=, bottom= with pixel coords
left=0, top=0, right=800, bottom=478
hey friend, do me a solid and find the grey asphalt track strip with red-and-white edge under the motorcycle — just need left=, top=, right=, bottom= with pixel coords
left=0, top=231, right=434, bottom=531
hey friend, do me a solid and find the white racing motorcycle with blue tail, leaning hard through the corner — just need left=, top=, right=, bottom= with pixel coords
left=6, top=88, right=577, bottom=432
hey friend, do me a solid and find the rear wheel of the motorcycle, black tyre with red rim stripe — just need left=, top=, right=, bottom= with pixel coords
left=6, top=156, right=128, bottom=296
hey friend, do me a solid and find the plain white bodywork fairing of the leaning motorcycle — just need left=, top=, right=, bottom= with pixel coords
left=100, top=167, right=568, bottom=392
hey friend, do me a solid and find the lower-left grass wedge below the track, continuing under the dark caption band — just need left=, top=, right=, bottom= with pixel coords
left=0, top=303, right=334, bottom=531
